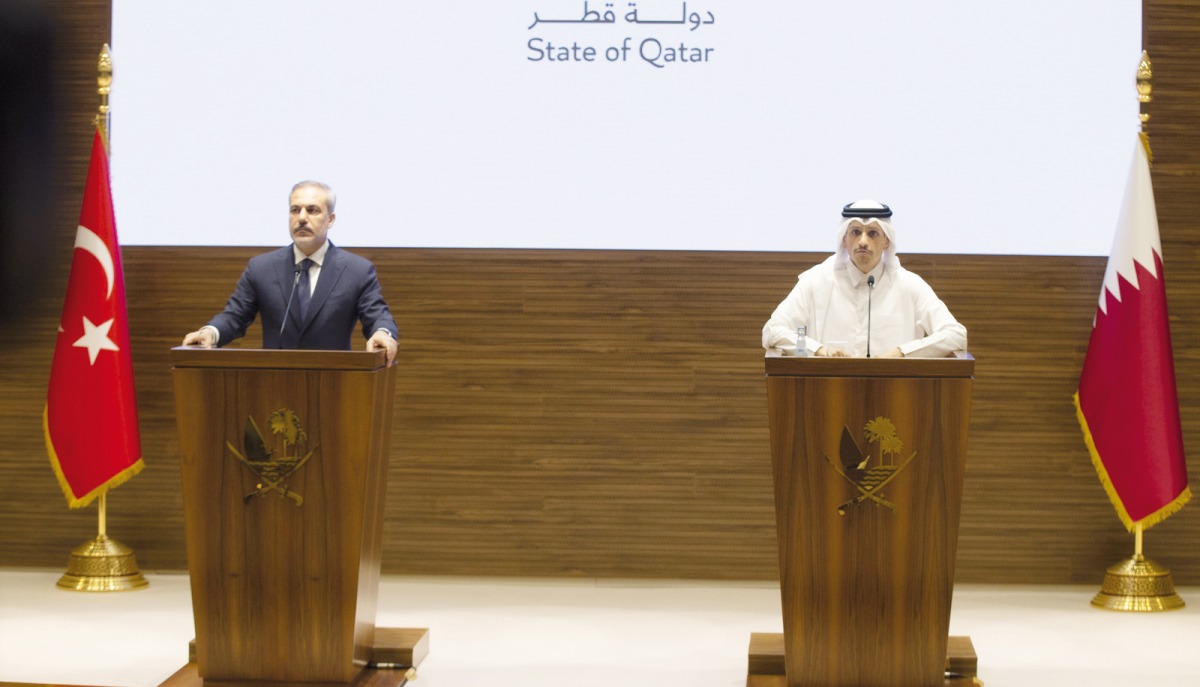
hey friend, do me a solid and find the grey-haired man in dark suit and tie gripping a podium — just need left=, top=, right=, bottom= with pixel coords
left=184, top=181, right=398, bottom=364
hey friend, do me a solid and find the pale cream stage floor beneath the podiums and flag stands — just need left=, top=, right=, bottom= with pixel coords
left=0, top=569, right=1200, bottom=687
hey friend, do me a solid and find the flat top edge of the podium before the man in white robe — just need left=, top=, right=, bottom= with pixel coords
left=763, top=351, right=974, bottom=377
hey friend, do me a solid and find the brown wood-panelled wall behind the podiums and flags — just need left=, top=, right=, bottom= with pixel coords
left=0, top=0, right=1200, bottom=584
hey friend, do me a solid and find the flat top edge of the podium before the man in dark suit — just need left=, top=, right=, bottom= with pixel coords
left=170, top=346, right=388, bottom=372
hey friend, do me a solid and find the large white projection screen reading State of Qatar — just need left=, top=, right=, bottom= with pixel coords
left=112, top=0, right=1141, bottom=255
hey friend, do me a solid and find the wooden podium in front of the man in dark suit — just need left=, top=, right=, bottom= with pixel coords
left=163, top=347, right=428, bottom=687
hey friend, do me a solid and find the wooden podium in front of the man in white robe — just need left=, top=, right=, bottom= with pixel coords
left=746, top=353, right=977, bottom=687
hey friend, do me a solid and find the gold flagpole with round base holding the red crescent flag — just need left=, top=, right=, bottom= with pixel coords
left=58, top=43, right=149, bottom=592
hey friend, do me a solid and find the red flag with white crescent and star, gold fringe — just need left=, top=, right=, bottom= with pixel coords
left=43, top=129, right=142, bottom=508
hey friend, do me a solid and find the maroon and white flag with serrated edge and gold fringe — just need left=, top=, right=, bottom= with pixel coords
left=1075, top=135, right=1192, bottom=531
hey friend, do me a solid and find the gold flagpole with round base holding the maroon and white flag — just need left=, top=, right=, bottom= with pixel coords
left=1092, top=50, right=1183, bottom=613
